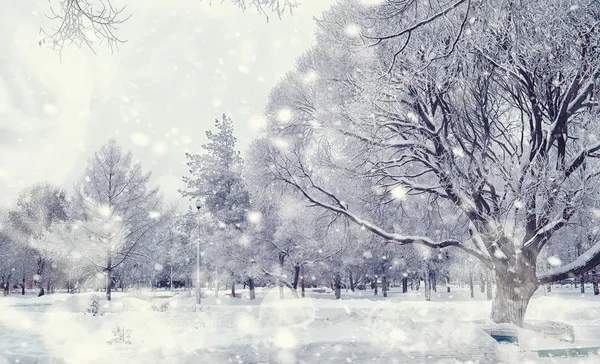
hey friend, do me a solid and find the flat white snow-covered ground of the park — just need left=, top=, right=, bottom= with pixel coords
left=0, top=287, right=600, bottom=364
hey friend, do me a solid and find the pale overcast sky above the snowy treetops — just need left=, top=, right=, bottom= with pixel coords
left=0, top=0, right=334, bottom=208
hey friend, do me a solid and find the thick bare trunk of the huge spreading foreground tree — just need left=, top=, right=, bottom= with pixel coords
left=491, top=261, right=538, bottom=327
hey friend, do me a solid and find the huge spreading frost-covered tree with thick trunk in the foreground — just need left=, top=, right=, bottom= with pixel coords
left=258, top=0, right=600, bottom=325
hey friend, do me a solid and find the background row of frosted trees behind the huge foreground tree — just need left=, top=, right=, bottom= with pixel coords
left=0, top=115, right=494, bottom=300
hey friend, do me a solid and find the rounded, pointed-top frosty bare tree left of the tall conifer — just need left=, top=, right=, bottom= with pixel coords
left=47, top=139, right=168, bottom=300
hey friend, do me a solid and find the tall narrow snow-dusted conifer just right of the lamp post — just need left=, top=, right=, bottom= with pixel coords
left=180, top=115, right=256, bottom=295
